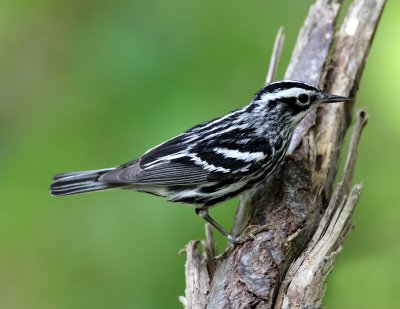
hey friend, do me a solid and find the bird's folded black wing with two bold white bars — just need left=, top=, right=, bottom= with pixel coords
left=99, top=114, right=265, bottom=186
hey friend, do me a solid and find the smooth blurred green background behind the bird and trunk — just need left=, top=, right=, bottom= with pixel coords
left=0, top=0, right=400, bottom=309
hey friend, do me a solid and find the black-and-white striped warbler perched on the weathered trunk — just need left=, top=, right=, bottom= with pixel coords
left=50, top=80, right=351, bottom=244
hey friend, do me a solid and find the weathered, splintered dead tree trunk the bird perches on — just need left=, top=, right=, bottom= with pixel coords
left=181, top=0, right=386, bottom=309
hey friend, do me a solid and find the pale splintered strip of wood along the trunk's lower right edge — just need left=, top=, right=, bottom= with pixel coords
left=275, top=110, right=368, bottom=308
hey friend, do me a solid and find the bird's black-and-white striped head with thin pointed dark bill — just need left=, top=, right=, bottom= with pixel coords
left=253, top=80, right=351, bottom=125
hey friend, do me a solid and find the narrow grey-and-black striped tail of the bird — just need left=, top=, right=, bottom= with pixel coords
left=50, top=168, right=118, bottom=196
